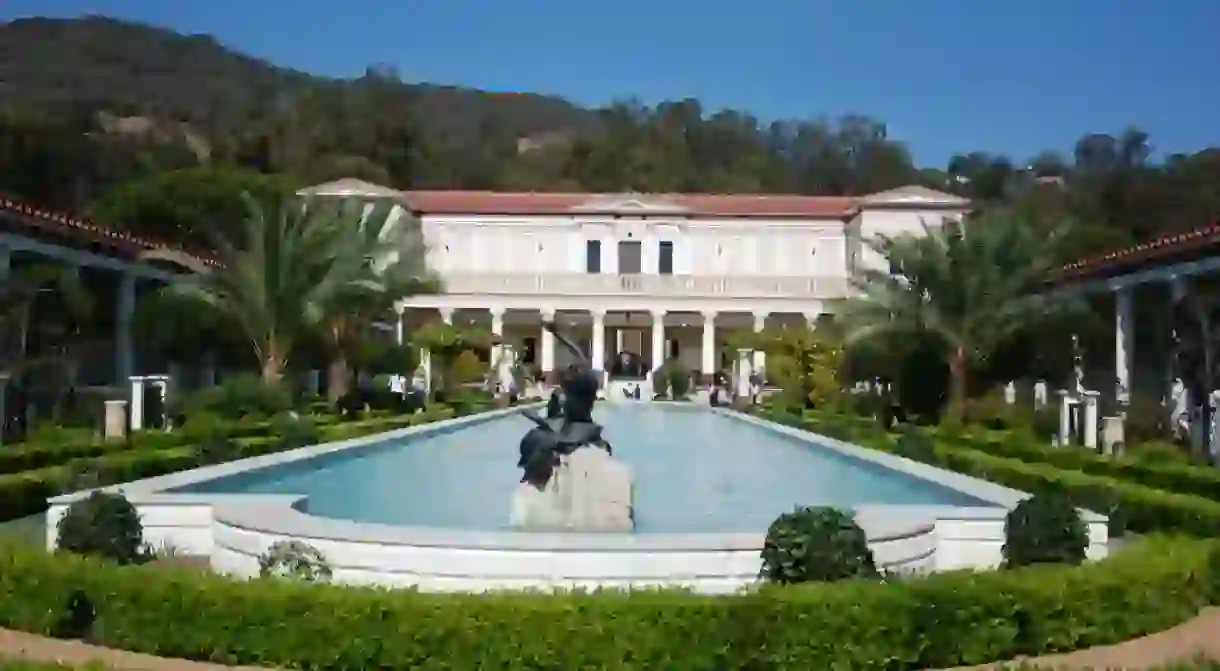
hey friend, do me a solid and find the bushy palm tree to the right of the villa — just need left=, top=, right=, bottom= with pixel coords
left=843, top=212, right=1069, bottom=418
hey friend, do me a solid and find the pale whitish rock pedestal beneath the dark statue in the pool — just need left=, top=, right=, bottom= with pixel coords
left=510, top=448, right=636, bottom=533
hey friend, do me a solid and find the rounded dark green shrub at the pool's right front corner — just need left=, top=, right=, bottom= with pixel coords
left=1004, top=492, right=1088, bottom=567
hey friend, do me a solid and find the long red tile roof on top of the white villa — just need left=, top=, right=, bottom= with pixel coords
left=403, top=190, right=856, bottom=218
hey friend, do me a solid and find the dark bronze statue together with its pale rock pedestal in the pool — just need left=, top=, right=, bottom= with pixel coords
left=512, top=322, right=634, bottom=532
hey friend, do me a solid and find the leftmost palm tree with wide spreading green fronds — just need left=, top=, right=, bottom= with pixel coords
left=144, top=195, right=384, bottom=382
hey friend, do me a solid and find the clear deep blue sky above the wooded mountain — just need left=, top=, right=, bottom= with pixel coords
left=7, top=0, right=1220, bottom=166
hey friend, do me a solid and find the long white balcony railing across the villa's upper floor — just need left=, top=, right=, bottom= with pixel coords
left=444, top=273, right=853, bottom=299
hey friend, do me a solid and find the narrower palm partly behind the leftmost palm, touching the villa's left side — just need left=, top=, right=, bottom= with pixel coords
left=325, top=201, right=439, bottom=401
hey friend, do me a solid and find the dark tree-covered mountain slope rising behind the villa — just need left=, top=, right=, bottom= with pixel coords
left=0, top=17, right=1220, bottom=254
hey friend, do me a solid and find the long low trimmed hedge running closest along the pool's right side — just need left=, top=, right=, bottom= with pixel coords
left=795, top=415, right=1220, bottom=537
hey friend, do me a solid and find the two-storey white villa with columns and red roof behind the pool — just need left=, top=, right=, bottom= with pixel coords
left=303, top=179, right=970, bottom=381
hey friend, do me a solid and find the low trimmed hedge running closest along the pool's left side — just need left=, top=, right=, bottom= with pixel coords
left=0, top=406, right=454, bottom=521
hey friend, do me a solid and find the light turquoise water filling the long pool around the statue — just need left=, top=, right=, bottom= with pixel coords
left=177, top=404, right=991, bottom=533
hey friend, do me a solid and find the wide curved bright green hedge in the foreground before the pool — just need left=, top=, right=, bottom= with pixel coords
left=0, top=537, right=1220, bottom=671
